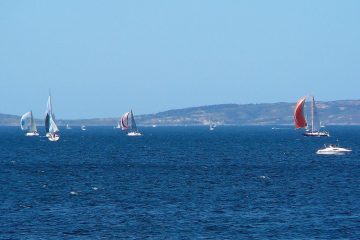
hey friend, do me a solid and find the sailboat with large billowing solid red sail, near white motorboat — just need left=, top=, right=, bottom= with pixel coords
left=294, top=96, right=330, bottom=137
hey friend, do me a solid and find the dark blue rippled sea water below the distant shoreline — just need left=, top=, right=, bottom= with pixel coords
left=0, top=126, right=360, bottom=239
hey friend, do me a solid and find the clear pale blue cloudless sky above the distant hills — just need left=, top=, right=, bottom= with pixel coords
left=0, top=0, right=360, bottom=118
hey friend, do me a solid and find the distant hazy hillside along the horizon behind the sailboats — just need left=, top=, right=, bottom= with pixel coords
left=0, top=100, right=360, bottom=126
